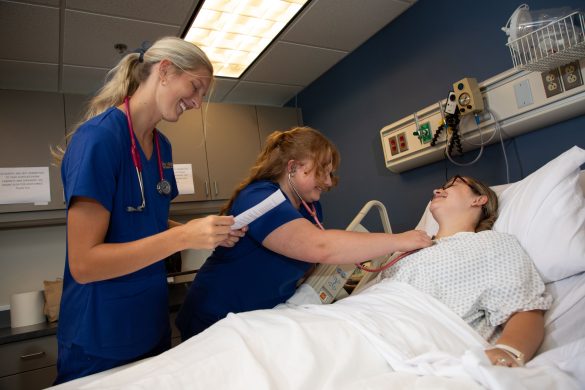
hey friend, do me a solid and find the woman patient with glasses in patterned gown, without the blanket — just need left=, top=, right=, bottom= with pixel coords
left=379, top=176, right=552, bottom=367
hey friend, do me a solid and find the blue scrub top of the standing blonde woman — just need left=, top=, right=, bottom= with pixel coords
left=58, top=107, right=178, bottom=360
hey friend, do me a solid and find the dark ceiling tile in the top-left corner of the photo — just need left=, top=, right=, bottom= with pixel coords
left=0, top=1, right=59, bottom=64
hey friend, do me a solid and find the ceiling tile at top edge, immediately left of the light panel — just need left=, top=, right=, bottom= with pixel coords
left=67, top=0, right=198, bottom=26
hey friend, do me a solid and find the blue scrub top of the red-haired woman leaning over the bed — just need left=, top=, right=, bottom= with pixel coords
left=176, top=181, right=322, bottom=339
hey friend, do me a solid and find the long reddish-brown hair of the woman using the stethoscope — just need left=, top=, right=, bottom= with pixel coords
left=220, top=127, right=340, bottom=214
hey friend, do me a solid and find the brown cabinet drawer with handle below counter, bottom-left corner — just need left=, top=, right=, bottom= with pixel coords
left=0, top=336, right=57, bottom=390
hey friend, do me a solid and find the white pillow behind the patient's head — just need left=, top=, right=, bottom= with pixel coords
left=416, top=146, right=585, bottom=282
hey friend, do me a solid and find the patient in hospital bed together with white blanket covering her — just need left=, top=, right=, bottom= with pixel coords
left=53, top=178, right=578, bottom=389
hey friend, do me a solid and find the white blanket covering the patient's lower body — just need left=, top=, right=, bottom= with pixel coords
left=57, top=281, right=579, bottom=390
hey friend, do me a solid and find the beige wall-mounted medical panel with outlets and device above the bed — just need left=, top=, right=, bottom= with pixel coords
left=380, top=59, right=585, bottom=173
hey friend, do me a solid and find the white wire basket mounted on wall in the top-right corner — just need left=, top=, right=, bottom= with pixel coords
left=506, top=11, right=585, bottom=72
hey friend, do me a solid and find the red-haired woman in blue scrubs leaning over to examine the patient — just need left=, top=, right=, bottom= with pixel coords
left=176, top=127, right=432, bottom=340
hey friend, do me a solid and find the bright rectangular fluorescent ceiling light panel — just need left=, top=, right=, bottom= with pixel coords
left=185, top=0, right=308, bottom=78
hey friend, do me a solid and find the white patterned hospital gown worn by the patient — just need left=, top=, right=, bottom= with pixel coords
left=380, top=230, right=552, bottom=341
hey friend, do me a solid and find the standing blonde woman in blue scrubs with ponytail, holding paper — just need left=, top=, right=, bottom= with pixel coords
left=55, top=37, right=243, bottom=384
